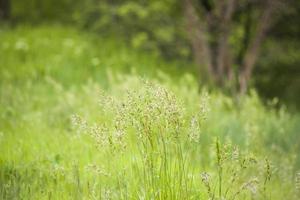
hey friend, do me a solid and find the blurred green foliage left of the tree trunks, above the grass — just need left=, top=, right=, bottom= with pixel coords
left=12, top=0, right=189, bottom=58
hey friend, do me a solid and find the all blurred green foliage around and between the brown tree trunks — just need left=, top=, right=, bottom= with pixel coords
left=6, top=0, right=300, bottom=107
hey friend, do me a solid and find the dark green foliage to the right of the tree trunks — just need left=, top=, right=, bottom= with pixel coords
left=254, top=0, right=300, bottom=109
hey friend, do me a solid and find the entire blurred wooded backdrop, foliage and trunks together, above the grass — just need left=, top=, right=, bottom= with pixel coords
left=0, top=0, right=300, bottom=108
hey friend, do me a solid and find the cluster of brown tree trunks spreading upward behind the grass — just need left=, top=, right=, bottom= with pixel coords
left=183, top=0, right=281, bottom=94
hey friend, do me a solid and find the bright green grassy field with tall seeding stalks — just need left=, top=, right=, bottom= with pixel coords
left=0, top=26, right=300, bottom=200
